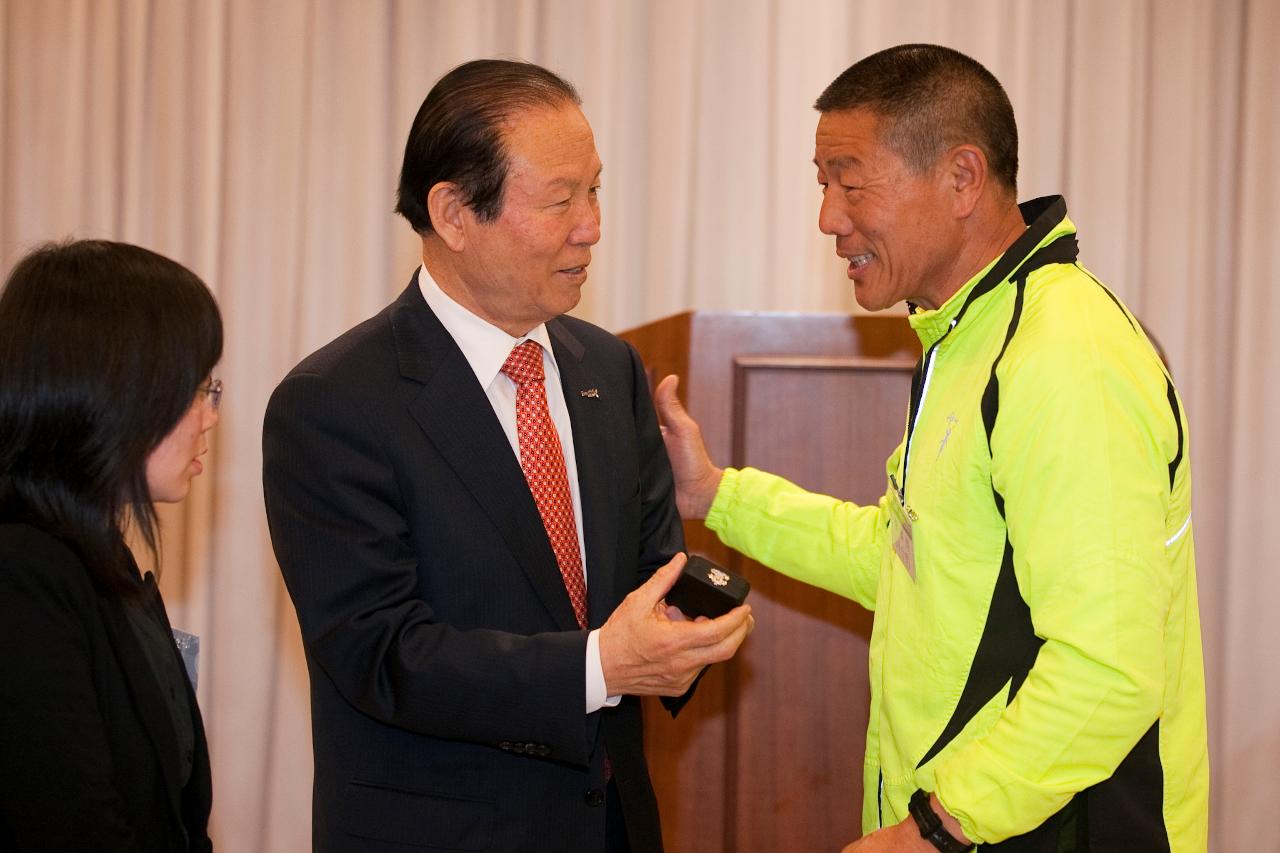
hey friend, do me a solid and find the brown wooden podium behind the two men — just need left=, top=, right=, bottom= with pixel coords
left=621, top=313, right=919, bottom=853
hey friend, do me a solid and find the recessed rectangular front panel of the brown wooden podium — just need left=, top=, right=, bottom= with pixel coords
left=728, top=357, right=913, bottom=853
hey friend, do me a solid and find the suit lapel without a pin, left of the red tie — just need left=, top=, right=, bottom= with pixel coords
left=392, top=275, right=577, bottom=630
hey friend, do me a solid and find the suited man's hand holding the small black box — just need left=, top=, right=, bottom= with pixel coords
left=600, top=555, right=755, bottom=695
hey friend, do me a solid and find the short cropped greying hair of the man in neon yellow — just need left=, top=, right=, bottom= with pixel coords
left=814, top=45, right=1018, bottom=193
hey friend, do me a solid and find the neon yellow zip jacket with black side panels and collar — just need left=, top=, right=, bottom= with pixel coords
left=707, top=197, right=1208, bottom=853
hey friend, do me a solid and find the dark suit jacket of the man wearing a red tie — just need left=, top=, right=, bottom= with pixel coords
left=264, top=278, right=684, bottom=853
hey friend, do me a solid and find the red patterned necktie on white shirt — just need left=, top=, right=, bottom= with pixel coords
left=502, top=341, right=586, bottom=629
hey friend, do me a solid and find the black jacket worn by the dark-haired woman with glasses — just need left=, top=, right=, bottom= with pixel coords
left=0, top=524, right=212, bottom=853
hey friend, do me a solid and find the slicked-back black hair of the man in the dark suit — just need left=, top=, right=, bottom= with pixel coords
left=396, top=59, right=582, bottom=237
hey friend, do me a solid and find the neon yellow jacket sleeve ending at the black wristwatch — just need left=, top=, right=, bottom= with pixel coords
left=936, top=311, right=1179, bottom=843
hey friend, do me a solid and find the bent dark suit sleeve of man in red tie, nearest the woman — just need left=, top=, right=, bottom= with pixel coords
left=262, top=373, right=590, bottom=765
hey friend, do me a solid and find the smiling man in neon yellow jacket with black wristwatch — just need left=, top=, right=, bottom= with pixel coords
left=658, top=45, right=1208, bottom=853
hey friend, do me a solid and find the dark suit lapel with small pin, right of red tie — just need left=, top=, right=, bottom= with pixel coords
left=547, top=320, right=622, bottom=628
